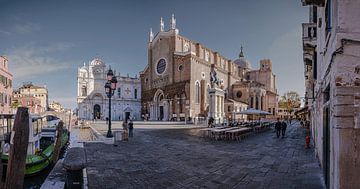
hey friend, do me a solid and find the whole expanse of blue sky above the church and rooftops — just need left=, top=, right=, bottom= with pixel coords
left=0, top=0, right=308, bottom=108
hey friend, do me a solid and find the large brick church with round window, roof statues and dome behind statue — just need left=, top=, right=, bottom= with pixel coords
left=140, top=16, right=277, bottom=121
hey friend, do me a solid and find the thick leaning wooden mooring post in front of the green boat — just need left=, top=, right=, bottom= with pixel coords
left=5, top=107, right=29, bottom=189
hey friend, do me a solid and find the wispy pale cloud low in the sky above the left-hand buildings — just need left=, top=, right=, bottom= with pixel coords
left=7, top=43, right=73, bottom=79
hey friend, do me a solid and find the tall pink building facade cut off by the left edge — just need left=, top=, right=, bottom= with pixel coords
left=0, top=56, right=13, bottom=114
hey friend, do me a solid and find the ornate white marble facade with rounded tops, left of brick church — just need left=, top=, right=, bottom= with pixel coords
left=77, top=58, right=141, bottom=120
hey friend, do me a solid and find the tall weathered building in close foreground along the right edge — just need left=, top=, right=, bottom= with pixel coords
left=302, top=0, right=360, bottom=189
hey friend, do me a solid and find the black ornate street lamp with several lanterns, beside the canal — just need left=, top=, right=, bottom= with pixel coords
left=105, top=68, right=117, bottom=138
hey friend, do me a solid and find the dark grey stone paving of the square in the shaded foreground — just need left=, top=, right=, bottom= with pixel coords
left=85, top=123, right=324, bottom=189
